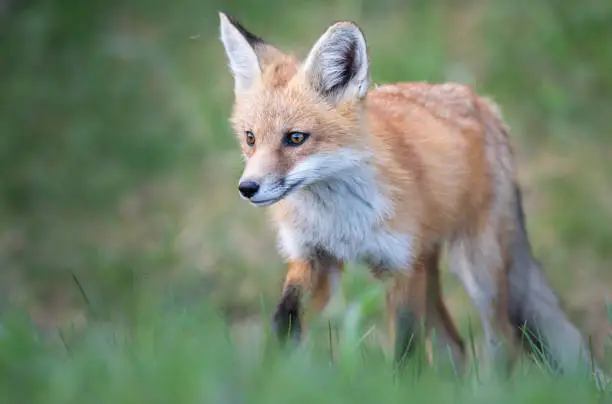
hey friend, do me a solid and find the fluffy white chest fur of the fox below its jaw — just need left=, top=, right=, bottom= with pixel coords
left=278, top=169, right=411, bottom=270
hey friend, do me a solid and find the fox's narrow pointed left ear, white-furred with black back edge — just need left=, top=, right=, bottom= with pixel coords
left=219, top=12, right=265, bottom=93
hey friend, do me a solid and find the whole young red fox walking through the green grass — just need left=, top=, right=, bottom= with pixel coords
left=219, top=12, right=601, bottom=382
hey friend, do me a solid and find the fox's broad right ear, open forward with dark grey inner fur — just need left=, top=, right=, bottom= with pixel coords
left=302, top=21, right=370, bottom=103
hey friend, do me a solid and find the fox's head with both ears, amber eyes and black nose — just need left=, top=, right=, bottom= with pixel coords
left=219, top=13, right=370, bottom=206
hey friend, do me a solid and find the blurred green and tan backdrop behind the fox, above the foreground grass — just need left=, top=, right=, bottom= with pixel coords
left=0, top=0, right=612, bottom=402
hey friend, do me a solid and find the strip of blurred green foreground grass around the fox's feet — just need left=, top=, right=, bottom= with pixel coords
left=0, top=288, right=608, bottom=403
